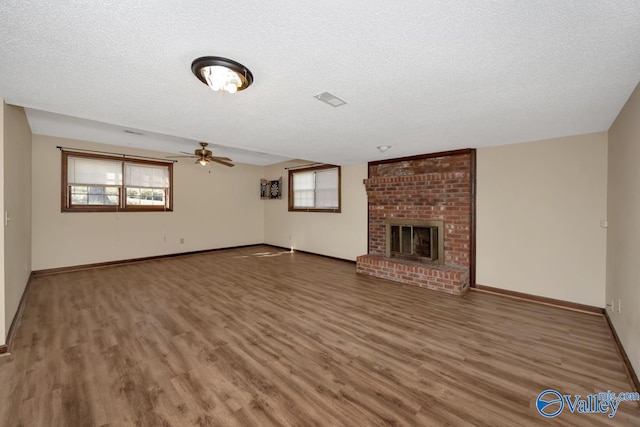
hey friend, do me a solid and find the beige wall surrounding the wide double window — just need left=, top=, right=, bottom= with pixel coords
left=32, top=135, right=264, bottom=270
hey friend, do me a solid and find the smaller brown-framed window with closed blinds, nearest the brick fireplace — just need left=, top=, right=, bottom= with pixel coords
left=289, top=165, right=340, bottom=212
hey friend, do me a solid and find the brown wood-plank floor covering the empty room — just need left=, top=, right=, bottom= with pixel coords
left=0, top=246, right=640, bottom=427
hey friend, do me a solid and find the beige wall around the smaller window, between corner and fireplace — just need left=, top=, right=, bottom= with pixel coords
left=263, top=162, right=367, bottom=261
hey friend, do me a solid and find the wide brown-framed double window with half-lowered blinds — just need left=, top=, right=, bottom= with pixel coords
left=62, top=151, right=173, bottom=212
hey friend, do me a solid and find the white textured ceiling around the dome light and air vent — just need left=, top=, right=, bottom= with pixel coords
left=0, top=0, right=640, bottom=165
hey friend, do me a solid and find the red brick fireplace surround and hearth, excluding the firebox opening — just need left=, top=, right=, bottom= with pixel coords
left=356, top=150, right=475, bottom=294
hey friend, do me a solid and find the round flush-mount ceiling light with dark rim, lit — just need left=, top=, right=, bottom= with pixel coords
left=191, top=56, right=253, bottom=93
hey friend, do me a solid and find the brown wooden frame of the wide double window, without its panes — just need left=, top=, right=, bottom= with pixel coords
left=60, top=150, right=173, bottom=212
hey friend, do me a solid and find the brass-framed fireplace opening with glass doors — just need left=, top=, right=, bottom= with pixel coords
left=386, top=219, right=444, bottom=264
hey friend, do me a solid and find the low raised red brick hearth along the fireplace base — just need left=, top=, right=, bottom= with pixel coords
left=356, top=255, right=469, bottom=295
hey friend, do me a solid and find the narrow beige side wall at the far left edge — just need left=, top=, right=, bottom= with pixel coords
left=3, top=105, right=31, bottom=337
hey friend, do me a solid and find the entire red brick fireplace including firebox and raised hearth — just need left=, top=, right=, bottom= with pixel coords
left=356, top=149, right=475, bottom=295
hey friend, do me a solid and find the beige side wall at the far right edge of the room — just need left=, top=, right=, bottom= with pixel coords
left=606, top=82, right=640, bottom=373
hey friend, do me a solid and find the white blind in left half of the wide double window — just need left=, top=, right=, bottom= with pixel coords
left=67, top=157, right=122, bottom=186
